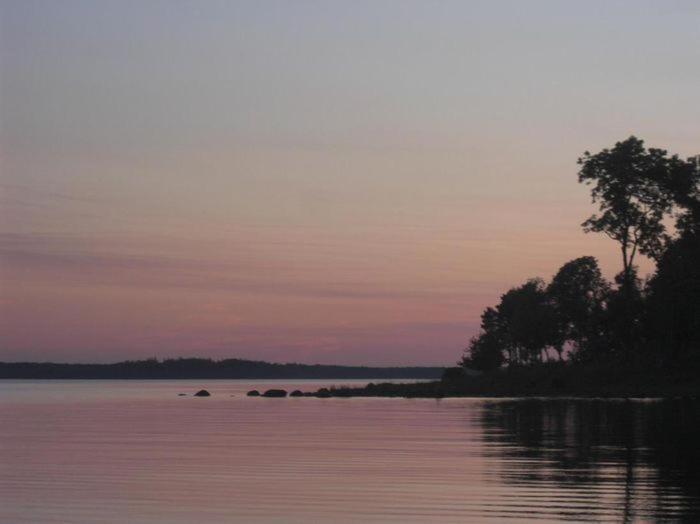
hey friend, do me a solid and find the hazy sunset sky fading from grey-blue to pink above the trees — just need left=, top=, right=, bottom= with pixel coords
left=0, top=0, right=700, bottom=365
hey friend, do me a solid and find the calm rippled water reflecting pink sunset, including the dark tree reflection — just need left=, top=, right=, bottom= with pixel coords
left=0, top=381, right=700, bottom=523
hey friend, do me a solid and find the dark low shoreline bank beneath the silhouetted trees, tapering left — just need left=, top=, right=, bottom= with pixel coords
left=318, top=364, right=700, bottom=398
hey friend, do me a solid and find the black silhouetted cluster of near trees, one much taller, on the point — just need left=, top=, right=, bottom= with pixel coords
left=461, top=136, right=700, bottom=374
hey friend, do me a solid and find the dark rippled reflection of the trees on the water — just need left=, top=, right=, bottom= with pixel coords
left=482, top=400, right=700, bottom=521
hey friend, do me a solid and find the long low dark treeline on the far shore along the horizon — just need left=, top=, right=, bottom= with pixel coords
left=0, top=358, right=444, bottom=379
